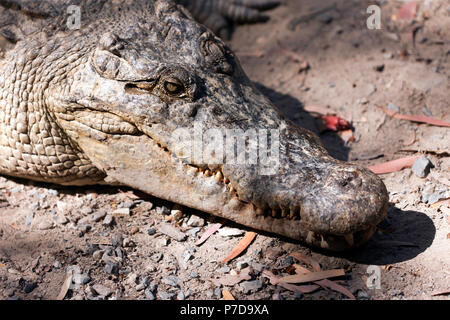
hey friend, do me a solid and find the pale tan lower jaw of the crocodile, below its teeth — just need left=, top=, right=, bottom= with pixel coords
left=78, top=136, right=375, bottom=251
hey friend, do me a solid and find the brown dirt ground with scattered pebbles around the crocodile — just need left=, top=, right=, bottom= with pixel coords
left=0, top=0, right=450, bottom=300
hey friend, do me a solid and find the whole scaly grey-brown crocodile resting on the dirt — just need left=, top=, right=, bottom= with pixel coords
left=0, top=0, right=388, bottom=251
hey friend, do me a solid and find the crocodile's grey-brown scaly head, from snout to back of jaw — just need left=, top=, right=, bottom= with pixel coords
left=46, top=2, right=388, bottom=250
